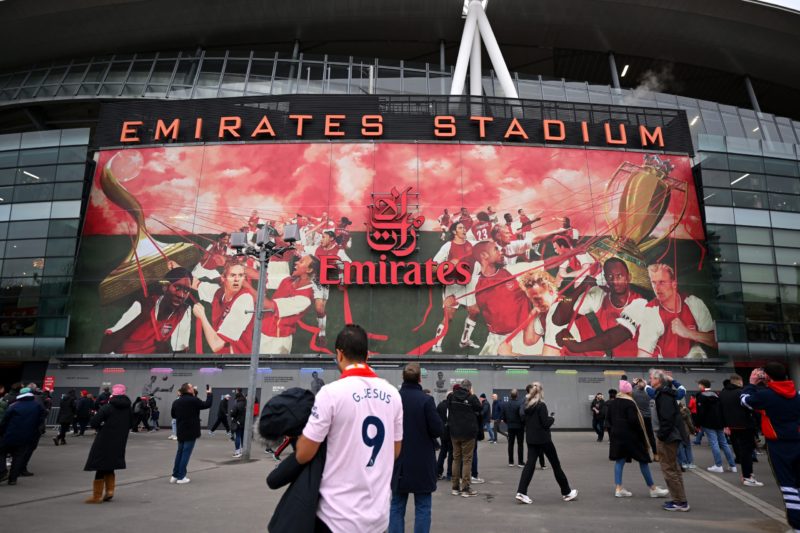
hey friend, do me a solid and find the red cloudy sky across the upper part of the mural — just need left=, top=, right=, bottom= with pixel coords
left=84, top=143, right=703, bottom=239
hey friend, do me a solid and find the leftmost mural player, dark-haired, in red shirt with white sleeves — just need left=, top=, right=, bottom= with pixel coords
left=100, top=267, right=192, bottom=353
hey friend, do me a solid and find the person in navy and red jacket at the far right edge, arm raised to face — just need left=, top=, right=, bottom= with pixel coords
left=741, top=362, right=800, bottom=531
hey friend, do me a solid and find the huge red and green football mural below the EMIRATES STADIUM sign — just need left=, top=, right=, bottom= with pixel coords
left=68, top=142, right=719, bottom=359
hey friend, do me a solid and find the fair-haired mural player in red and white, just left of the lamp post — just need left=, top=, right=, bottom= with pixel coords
left=192, top=261, right=255, bottom=353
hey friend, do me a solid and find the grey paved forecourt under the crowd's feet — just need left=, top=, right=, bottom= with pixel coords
left=0, top=430, right=788, bottom=533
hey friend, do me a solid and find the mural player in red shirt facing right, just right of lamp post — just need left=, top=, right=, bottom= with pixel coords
left=259, top=255, right=319, bottom=354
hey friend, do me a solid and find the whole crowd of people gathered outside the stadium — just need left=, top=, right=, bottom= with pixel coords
left=0, top=342, right=800, bottom=533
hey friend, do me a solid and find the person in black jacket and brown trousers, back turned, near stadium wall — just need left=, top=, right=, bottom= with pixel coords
left=447, top=379, right=481, bottom=498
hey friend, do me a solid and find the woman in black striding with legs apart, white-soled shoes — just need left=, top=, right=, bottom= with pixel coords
left=516, top=381, right=578, bottom=504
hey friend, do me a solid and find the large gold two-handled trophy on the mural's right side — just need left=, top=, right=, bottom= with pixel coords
left=588, top=155, right=689, bottom=289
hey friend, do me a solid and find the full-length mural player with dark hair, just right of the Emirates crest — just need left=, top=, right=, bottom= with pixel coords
left=431, top=221, right=480, bottom=353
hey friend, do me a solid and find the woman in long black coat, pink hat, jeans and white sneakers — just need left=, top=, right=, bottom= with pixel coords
left=606, top=380, right=669, bottom=498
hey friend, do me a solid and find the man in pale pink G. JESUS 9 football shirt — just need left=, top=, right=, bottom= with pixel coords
left=295, top=324, right=403, bottom=533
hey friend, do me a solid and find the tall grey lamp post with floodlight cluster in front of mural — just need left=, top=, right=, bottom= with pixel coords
left=231, top=224, right=298, bottom=460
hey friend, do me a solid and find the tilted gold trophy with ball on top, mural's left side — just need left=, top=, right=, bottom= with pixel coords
left=100, top=150, right=200, bottom=305
